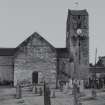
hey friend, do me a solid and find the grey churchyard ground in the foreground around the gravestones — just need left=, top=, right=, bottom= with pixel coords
left=0, top=83, right=105, bottom=105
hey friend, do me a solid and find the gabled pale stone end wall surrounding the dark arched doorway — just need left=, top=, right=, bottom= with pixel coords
left=14, top=35, right=56, bottom=88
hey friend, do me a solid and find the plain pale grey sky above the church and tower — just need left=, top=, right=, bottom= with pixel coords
left=0, top=0, right=105, bottom=63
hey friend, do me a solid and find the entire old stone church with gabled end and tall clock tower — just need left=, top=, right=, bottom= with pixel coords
left=0, top=10, right=89, bottom=87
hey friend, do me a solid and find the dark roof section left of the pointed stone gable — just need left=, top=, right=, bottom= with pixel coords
left=0, top=48, right=15, bottom=56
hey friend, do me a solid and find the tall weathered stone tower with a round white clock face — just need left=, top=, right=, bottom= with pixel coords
left=66, top=10, right=89, bottom=78
